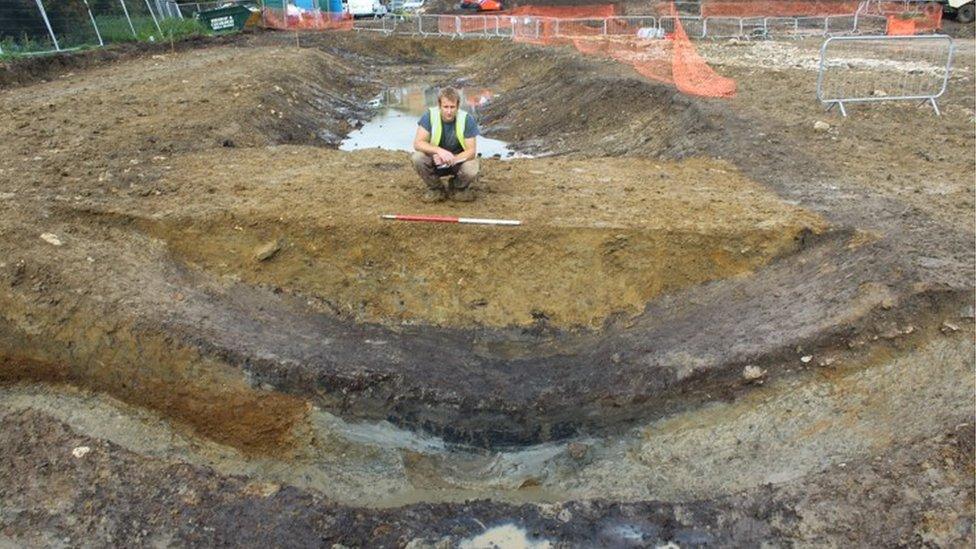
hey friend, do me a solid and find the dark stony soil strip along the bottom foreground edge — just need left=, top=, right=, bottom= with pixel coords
left=0, top=396, right=974, bottom=547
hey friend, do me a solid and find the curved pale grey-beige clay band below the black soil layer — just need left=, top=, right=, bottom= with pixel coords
left=0, top=326, right=973, bottom=507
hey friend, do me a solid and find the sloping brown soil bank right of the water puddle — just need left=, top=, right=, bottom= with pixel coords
left=468, top=47, right=730, bottom=158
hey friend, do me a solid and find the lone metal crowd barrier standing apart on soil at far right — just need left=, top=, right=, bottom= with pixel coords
left=817, top=34, right=955, bottom=116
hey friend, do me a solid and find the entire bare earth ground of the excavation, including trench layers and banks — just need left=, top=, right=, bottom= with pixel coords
left=0, top=30, right=976, bottom=547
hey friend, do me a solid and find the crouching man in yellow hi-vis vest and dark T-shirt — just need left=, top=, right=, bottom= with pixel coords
left=413, top=88, right=478, bottom=202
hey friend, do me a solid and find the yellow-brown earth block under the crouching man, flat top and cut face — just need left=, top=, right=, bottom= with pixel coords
left=118, top=149, right=826, bottom=329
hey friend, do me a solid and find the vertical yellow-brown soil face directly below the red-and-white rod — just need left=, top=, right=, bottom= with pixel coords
left=141, top=218, right=809, bottom=328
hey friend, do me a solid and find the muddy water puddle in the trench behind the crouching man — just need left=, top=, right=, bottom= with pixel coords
left=339, top=86, right=528, bottom=159
